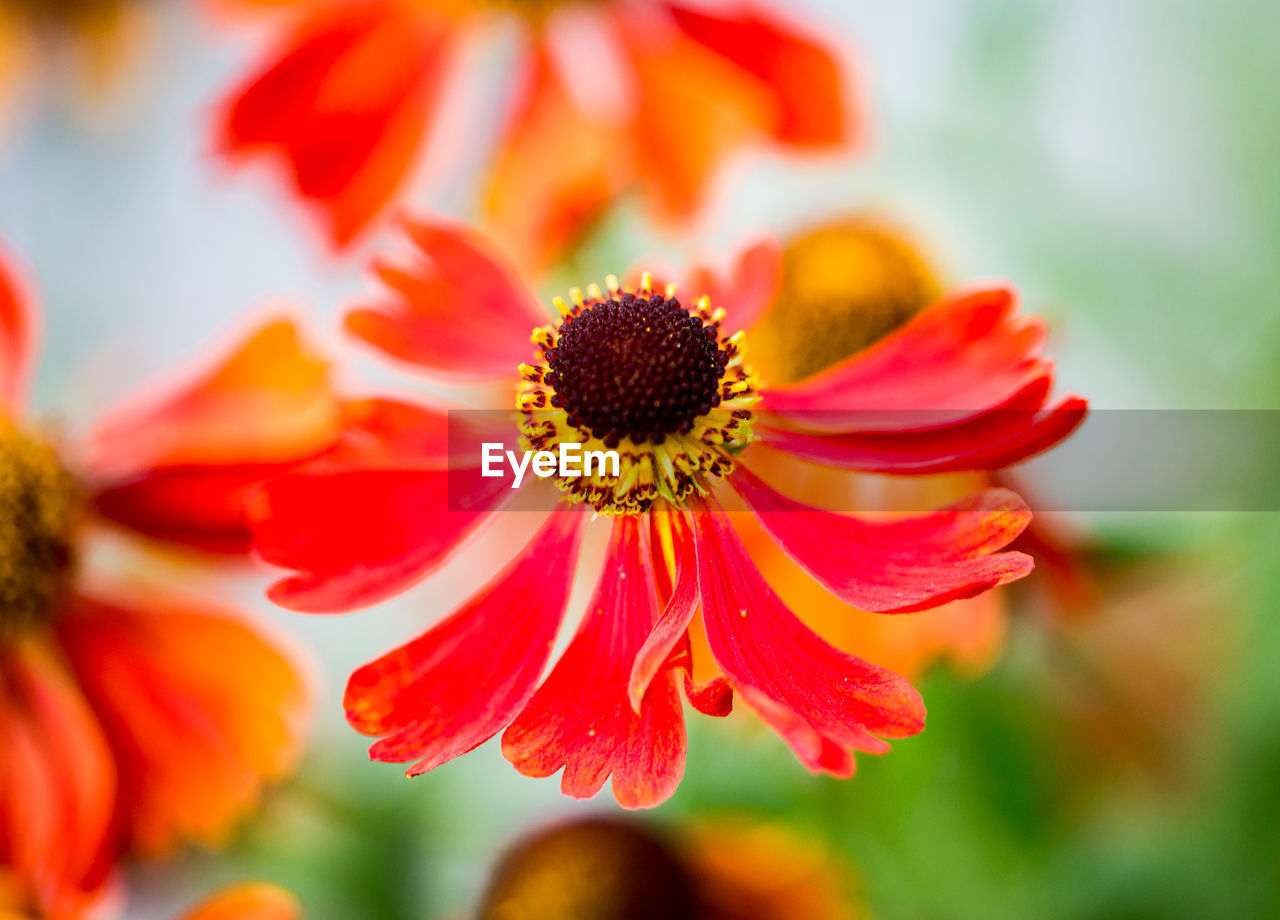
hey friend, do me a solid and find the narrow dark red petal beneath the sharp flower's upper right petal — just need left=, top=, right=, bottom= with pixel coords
left=756, top=397, right=1088, bottom=475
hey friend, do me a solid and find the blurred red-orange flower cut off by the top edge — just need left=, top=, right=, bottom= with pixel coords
left=218, top=0, right=852, bottom=264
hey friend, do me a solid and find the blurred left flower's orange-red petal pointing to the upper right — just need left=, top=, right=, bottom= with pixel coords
left=86, top=320, right=342, bottom=554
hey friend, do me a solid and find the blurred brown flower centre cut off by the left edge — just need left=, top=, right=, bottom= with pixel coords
left=0, top=421, right=79, bottom=640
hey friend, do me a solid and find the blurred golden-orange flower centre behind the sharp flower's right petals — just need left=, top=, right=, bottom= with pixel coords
left=751, top=219, right=941, bottom=385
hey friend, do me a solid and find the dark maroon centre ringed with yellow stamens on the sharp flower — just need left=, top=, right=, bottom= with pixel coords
left=517, top=275, right=758, bottom=514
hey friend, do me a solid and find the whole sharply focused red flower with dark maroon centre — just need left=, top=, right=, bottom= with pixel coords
left=244, top=224, right=1084, bottom=806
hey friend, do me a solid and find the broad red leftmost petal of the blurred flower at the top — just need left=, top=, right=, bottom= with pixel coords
left=216, top=0, right=454, bottom=246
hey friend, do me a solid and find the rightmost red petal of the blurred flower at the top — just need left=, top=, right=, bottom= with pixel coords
left=671, top=4, right=851, bottom=147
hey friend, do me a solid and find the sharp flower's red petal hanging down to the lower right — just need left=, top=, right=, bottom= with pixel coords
left=694, top=509, right=924, bottom=775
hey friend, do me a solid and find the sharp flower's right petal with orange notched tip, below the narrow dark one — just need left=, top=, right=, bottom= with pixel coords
left=730, top=466, right=1034, bottom=613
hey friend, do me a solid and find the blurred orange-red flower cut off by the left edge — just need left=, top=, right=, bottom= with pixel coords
left=0, top=246, right=339, bottom=920
